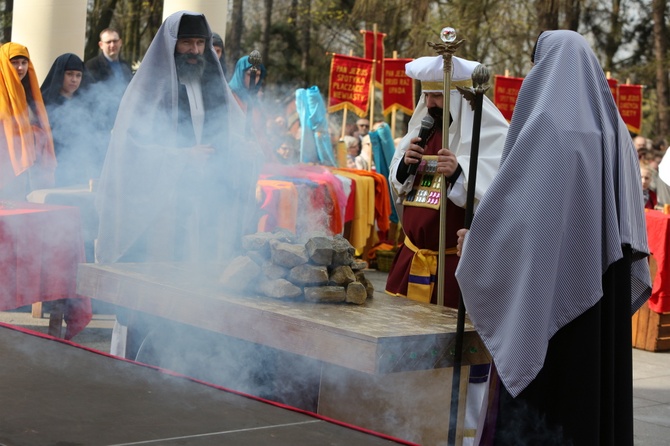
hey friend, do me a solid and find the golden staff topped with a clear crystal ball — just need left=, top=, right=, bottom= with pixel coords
left=428, top=26, right=465, bottom=306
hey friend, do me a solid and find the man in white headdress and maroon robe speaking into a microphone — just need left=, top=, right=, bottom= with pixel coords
left=386, top=56, right=508, bottom=308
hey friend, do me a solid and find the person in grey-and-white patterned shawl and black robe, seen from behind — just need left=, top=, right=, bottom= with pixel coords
left=456, top=30, right=651, bottom=446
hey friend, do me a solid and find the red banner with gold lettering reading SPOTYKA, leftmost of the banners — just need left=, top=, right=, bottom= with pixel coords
left=328, top=54, right=372, bottom=116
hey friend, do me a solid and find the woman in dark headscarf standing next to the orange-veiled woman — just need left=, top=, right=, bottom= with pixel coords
left=41, top=53, right=102, bottom=186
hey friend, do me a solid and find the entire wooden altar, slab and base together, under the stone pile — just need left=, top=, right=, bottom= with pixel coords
left=77, top=264, right=490, bottom=445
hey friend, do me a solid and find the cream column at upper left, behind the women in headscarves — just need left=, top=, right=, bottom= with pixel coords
left=11, top=0, right=87, bottom=84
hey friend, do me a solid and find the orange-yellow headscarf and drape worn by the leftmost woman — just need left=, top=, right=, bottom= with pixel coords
left=0, top=42, right=56, bottom=187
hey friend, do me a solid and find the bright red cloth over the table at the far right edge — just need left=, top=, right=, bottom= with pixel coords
left=646, top=210, right=670, bottom=313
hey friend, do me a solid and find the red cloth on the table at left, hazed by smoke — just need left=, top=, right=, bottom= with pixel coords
left=0, top=201, right=92, bottom=339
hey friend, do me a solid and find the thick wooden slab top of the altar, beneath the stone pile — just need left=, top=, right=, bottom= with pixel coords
left=77, top=263, right=490, bottom=374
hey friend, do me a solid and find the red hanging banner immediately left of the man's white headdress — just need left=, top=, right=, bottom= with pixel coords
left=382, top=59, right=415, bottom=115
